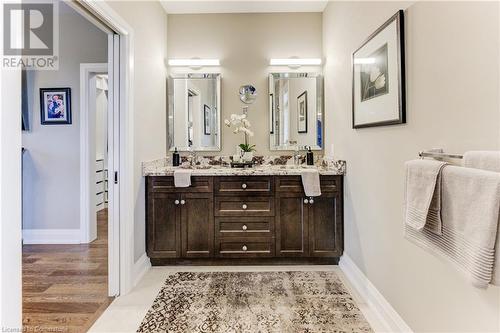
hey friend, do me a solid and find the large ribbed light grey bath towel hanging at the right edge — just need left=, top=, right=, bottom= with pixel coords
left=405, top=166, right=500, bottom=288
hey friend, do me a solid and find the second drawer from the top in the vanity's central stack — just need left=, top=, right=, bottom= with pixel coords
left=215, top=197, right=274, bottom=216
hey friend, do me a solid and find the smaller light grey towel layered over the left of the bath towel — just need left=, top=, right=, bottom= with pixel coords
left=405, top=160, right=446, bottom=235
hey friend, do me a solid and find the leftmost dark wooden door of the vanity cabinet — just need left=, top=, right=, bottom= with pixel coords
left=146, top=192, right=181, bottom=258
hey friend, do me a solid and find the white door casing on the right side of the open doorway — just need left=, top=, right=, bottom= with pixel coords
left=75, top=0, right=135, bottom=295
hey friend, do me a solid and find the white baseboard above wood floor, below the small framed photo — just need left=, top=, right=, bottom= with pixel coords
left=23, top=229, right=81, bottom=244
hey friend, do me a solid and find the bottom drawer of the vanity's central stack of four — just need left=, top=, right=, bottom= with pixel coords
left=216, top=238, right=274, bottom=258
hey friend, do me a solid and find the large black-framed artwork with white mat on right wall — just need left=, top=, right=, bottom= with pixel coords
left=352, top=10, right=406, bottom=128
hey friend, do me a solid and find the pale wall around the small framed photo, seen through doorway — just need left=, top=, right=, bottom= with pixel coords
left=22, top=2, right=107, bottom=230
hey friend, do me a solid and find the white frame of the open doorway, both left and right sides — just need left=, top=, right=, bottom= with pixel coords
left=0, top=0, right=135, bottom=329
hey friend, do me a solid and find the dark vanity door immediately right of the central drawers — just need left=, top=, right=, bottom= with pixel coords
left=276, top=193, right=308, bottom=257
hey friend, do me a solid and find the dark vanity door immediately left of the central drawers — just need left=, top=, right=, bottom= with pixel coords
left=180, top=193, right=214, bottom=258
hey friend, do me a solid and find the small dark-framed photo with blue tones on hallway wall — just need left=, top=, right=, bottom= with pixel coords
left=40, top=88, right=71, bottom=125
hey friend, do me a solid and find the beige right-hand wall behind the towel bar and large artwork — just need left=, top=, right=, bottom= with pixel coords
left=323, top=2, right=500, bottom=332
